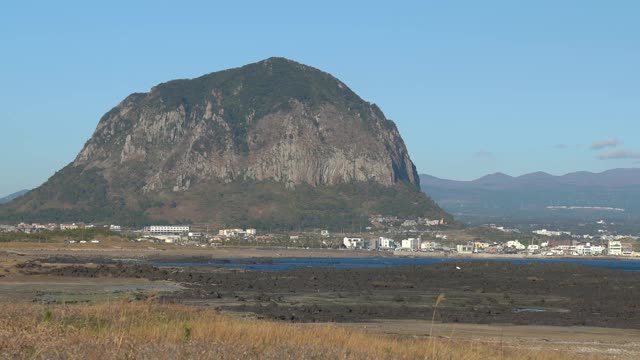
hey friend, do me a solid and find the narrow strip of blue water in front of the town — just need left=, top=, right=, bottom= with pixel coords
left=153, top=257, right=640, bottom=272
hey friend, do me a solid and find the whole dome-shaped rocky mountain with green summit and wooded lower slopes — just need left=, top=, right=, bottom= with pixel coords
left=0, top=58, right=450, bottom=226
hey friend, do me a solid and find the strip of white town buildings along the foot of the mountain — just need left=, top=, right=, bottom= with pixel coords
left=0, top=216, right=640, bottom=257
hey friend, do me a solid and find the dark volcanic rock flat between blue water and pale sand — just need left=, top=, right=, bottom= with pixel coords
left=32, top=261, right=640, bottom=328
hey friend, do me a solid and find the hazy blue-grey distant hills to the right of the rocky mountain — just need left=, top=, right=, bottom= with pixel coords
left=420, top=168, right=640, bottom=222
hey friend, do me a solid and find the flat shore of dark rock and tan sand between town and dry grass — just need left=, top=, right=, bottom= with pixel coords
left=0, top=244, right=640, bottom=359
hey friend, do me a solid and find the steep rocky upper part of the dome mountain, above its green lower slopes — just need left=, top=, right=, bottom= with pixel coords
left=73, top=58, right=419, bottom=192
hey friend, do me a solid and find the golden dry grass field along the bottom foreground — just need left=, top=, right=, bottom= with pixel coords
left=0, top=301, right=596, bottom=360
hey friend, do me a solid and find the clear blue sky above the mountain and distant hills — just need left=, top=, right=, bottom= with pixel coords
left=0, top=0, right=640, bottom=195
